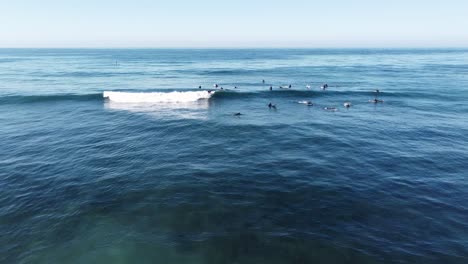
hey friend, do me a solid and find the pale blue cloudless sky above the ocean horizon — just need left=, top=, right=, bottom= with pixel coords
left=0, top=0, right=468, bottom=48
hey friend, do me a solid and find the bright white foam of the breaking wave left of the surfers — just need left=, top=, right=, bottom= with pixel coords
left=103, top=91, right=214, bottom=103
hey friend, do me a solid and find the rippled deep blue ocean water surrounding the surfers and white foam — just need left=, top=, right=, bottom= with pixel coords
left=0, top=49, right=468, bottom=263
